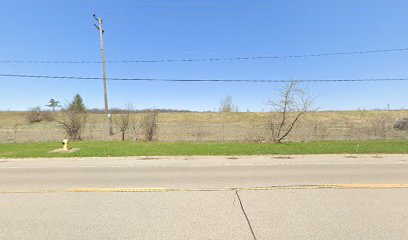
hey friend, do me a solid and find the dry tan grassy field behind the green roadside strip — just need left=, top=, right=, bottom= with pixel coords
left=0, top=110, right=408, bottom=143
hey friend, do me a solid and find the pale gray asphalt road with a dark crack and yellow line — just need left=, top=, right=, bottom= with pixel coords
left=0, top=155, right=408, bottom=239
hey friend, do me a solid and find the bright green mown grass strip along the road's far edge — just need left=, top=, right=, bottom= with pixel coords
left=0, top=140, right=408, bottom=158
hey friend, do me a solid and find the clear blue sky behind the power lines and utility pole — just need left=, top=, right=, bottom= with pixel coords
left=0, top=0, right=408, bottom=111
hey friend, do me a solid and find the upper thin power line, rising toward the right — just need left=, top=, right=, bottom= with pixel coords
left=0, top=48, right=408, bottom=64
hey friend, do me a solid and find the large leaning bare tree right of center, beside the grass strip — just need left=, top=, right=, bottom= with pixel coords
left=267, top=81, right=314, bottom=143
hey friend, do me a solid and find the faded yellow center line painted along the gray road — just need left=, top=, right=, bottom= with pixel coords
left=0, top=183, right=408, bottom=194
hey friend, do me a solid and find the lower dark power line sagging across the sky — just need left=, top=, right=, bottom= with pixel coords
left=0, top=73, right=408, bottom=83
